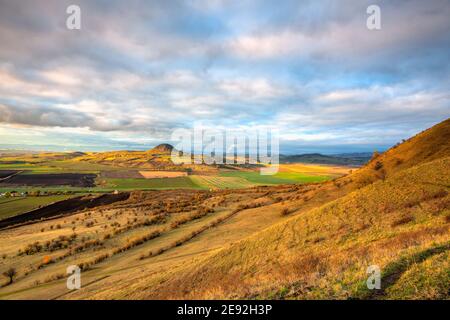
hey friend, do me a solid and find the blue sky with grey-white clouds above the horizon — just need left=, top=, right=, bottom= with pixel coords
left=0, top=0, right=450, bottom=153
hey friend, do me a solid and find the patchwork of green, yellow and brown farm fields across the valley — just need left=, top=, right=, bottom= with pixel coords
left=0, top=148, right=354, bottom=217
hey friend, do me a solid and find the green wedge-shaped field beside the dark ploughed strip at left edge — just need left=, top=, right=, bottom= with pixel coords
left=0, top=195, right=73, bottom=220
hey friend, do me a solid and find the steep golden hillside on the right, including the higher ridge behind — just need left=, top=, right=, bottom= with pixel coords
left=60, top=120, right=450, bottom=299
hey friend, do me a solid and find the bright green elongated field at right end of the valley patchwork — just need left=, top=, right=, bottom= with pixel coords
left=220, top=171, right=330, bottom=184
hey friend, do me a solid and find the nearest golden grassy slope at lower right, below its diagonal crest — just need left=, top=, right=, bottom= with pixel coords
left=142, top=157, right=450, bottom=298
